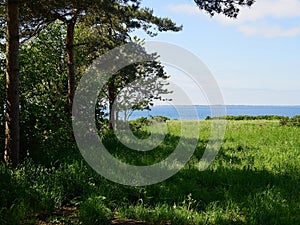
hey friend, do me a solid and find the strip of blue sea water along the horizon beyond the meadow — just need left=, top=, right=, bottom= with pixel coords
left=130, top=105, right=300, bottom=120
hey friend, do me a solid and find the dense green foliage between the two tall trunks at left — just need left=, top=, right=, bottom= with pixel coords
left=20, top=23, right=76, bottom=163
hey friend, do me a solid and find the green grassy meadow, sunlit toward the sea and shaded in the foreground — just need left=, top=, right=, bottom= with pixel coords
left=0, top=120, right=300, bottom=225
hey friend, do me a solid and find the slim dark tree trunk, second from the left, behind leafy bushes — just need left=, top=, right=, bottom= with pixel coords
left=66, top=20, right=75, bottom=116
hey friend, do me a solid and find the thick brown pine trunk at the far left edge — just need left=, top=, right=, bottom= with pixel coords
left=4, top=0, right=20, bottom=167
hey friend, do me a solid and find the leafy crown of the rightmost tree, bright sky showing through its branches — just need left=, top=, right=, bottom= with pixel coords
left=108, top=55, right=171, bottom=113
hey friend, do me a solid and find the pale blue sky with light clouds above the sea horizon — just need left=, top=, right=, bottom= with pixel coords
left=136, top=0, right=300, bottom=105
